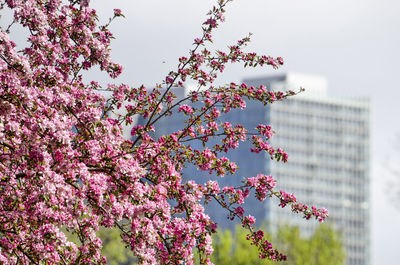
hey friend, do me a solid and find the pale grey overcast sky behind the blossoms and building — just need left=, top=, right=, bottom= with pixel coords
left=91, top=0, right=400, bottom=265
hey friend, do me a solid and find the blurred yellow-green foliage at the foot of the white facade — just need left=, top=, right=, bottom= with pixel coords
left=211, top=224, right=345, bottom=265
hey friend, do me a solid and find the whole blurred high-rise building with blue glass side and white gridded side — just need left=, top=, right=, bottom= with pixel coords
left=142, top=73, right=370, bottom=265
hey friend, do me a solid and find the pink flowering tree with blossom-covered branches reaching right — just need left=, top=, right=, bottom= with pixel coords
left=0, top=0, right=327, bottom=264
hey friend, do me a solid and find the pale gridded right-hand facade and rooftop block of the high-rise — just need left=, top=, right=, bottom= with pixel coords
left=244, top=73, right=370, bottom=265
